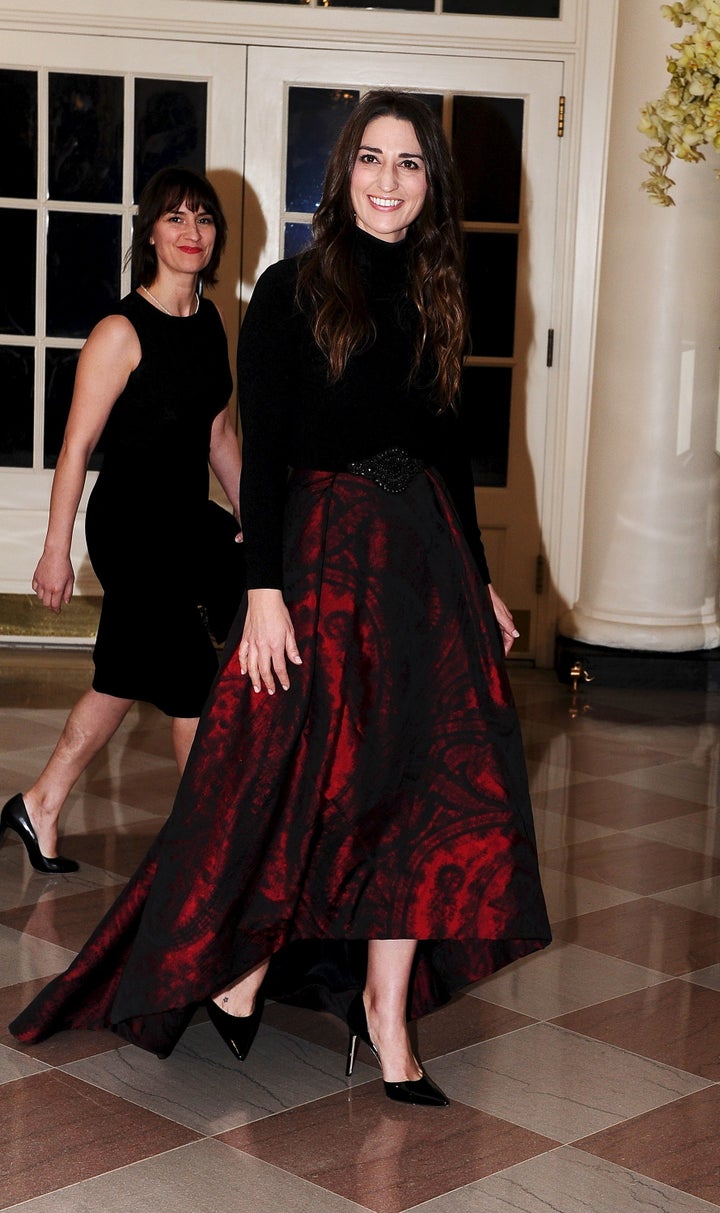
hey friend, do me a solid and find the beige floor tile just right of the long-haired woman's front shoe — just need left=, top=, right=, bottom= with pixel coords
left=433, top=1024, right=708, bottom=1144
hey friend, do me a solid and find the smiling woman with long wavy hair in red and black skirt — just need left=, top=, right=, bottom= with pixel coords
left=12, top=90, right=549, bottom=1106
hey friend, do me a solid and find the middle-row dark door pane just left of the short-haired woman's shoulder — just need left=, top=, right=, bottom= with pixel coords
left=47, top=211, right=121, bottom=337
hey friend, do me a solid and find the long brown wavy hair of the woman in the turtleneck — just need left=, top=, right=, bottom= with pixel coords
left=297, top=89, right=468, bottom=409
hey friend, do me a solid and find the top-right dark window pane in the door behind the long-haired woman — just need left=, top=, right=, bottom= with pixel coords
left=452, top=96, right=524, bottom=223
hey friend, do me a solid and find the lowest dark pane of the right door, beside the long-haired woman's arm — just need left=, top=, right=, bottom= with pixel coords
left=463, top=366, right=513, bottom=488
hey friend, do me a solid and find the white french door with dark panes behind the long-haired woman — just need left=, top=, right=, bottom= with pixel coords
left=242, top=46, right=564, bottom=661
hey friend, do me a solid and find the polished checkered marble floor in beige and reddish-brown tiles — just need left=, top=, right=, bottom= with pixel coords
left=0, top=649, right=720, bottom=1213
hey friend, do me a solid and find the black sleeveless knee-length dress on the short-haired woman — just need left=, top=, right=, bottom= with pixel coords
left=85, top=292, right=233, bottom=717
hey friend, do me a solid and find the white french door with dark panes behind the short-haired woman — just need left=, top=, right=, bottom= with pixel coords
left=0, top=32, right=245, bottom=606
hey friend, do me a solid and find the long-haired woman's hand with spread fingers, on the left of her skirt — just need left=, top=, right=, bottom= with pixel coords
left=238, top=590, right=302, bottom=695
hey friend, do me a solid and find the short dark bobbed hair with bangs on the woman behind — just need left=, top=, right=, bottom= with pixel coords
left=130, top=165, right=228, bottom=286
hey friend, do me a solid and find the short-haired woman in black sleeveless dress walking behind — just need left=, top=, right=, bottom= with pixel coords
left=0, top=167, right=242, bottom=872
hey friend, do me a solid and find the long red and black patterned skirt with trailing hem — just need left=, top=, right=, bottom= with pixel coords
left=11, top=472, right=550, bottom=1055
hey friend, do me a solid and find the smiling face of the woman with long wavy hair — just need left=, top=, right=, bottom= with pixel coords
left=350, top=114, right=428, bottom=243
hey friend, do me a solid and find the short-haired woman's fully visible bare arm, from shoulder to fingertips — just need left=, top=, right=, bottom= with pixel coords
left=33, top=315, right=141, bottom=614
